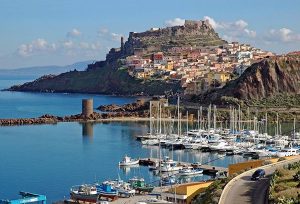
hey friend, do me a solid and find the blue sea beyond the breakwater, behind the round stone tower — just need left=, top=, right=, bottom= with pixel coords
left=0, top=80, right=136, bottom=118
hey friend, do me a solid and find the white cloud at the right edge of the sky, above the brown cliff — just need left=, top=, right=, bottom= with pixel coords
left=266, top=28, right=300, bottom=42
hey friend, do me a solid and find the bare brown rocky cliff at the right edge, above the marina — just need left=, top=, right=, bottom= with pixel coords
left=200, top=53, right=300, bottom=103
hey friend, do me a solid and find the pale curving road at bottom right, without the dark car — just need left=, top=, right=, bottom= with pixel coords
left=219, top=158, right=300, bottom=204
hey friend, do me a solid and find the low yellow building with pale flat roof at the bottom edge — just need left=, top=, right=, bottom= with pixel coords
left=161, top=181, right=213, bottom=204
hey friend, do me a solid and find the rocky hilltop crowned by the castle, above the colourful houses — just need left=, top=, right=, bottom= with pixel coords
left=124, top=20, right=227, bottom=54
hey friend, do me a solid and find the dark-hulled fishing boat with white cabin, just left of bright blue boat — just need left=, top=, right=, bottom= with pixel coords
left=70, top=184, right=99, bottom=203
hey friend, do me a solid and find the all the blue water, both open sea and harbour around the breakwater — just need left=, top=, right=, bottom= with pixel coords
left=0, top=80, right=244, bottom=202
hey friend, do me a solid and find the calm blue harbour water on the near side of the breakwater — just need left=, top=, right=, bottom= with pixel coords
left=0, top=122, right=243, bottom=201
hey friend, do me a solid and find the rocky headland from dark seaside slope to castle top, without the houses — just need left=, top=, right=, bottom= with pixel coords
left=8, top=21, right=227, bottom=95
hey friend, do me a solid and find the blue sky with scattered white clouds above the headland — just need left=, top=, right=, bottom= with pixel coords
left=0, top=0, right=300, bottom=69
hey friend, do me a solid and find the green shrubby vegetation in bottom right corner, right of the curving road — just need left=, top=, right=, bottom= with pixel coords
left=269, top=162, right=300, bottom=204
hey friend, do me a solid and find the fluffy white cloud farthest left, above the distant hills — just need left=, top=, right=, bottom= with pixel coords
left=17, top=38, right=57, bottom=57
